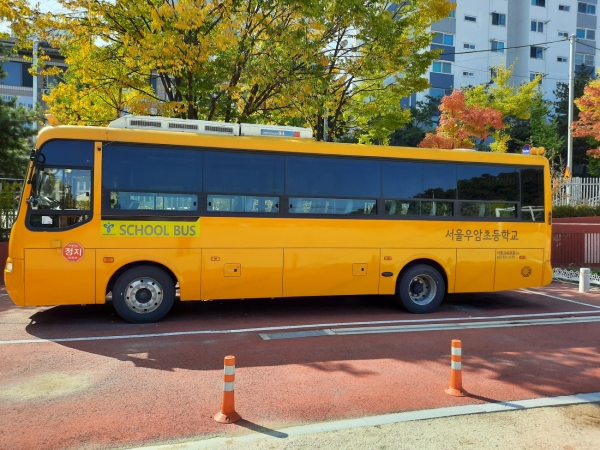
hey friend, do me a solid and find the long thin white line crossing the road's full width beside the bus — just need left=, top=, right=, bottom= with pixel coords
left=0, top=310, right=600, bottom=345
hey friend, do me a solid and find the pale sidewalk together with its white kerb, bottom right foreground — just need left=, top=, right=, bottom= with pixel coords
left=127, top=393, right=600, bottom=450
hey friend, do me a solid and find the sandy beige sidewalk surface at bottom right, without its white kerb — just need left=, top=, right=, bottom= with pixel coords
left=224, top=403, right=600, bottom=450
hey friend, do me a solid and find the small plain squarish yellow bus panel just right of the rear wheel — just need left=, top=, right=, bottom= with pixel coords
left=454, top=248, right=496, bottom=292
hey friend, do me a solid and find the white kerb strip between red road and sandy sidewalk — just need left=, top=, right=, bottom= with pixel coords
left=130, top=392, right=600, bottom=450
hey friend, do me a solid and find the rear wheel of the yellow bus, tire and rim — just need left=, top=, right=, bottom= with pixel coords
left=396, top=264, right=446, bottom=314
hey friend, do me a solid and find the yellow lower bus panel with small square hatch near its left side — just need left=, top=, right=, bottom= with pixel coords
left=202, top=248, right=283, bottom=300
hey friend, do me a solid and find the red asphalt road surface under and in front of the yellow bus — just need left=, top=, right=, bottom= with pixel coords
left=0, top=283, right=600, bottom=450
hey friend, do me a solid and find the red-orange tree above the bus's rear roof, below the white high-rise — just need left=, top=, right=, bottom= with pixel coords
left=418, top=89, right=504, bottom=148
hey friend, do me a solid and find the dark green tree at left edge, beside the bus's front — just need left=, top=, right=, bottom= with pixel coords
left=0, top=46, right=41, bottom=178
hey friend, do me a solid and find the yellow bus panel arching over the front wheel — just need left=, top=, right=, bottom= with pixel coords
left=96, top=248, right=201, bottom=303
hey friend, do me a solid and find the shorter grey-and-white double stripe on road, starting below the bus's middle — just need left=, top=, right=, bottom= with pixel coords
left=259, top=316, right=600, bottom=341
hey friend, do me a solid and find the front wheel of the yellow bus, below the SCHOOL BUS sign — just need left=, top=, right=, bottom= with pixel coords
left=113, top=266, right=175, bottom=323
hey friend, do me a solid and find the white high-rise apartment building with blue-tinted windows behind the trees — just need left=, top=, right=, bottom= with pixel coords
left=403, top=0, right=600, bottom=106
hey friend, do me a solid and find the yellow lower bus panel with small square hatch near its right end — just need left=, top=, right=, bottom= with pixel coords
left=283, top=248, right=380, bottom=297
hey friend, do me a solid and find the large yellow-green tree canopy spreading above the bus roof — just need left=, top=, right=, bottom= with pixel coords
left=0, top=0, right=454, bottom=141
